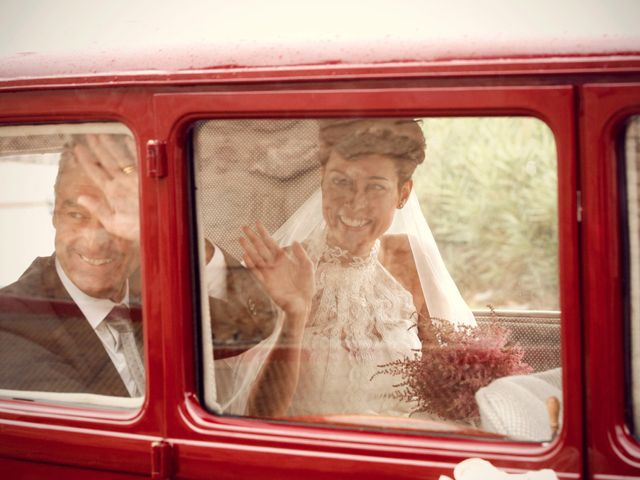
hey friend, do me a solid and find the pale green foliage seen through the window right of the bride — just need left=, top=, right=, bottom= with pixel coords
left=414, top=117, right=558, bottom=309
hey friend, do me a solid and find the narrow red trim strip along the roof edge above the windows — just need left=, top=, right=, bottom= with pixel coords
left=0, top=56, right=640, bottom=91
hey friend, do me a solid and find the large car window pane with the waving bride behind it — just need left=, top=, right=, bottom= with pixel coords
left=192, top=117, right=562, bottom=441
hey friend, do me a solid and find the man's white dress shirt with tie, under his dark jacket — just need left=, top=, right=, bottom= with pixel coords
left=55, top=257, right=136, bottom=396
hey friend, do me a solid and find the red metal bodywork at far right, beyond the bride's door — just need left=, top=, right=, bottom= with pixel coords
left=580, top=84, right=640, bottom=478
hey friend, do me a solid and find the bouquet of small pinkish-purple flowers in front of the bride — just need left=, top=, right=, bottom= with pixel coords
left=378, top=310, right=532, bottom=423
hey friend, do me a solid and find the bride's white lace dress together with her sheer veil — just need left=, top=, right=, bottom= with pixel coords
left=206, top=190, right=475, bottom=416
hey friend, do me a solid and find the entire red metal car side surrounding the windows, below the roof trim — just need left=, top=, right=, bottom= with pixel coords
left=0, top=67, right=640, bottom=478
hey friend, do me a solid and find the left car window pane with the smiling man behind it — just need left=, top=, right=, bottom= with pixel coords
left=0, top=123, right=145, bottom=407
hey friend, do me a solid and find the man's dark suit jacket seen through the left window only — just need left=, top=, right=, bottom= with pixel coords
left=0, top=256, right=142, bottom=396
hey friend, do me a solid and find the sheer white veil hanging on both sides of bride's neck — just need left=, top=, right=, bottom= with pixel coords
left=273, top=189, right=476, bottom=325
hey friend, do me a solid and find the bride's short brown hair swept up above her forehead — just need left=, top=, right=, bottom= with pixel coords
left=319, top=118, right=426, bottom=185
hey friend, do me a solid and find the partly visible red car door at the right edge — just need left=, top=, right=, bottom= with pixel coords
left=580, top=83, right=640, bottom=479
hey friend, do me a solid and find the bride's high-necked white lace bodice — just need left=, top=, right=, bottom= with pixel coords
left=289, top=232, right=420, bottom=415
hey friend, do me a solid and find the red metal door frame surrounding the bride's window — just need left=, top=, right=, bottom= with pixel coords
left=155, top=84, right=583, bottom=478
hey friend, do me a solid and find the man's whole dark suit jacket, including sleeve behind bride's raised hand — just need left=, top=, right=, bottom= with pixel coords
left=0, top=255, right=276, bottom=396
